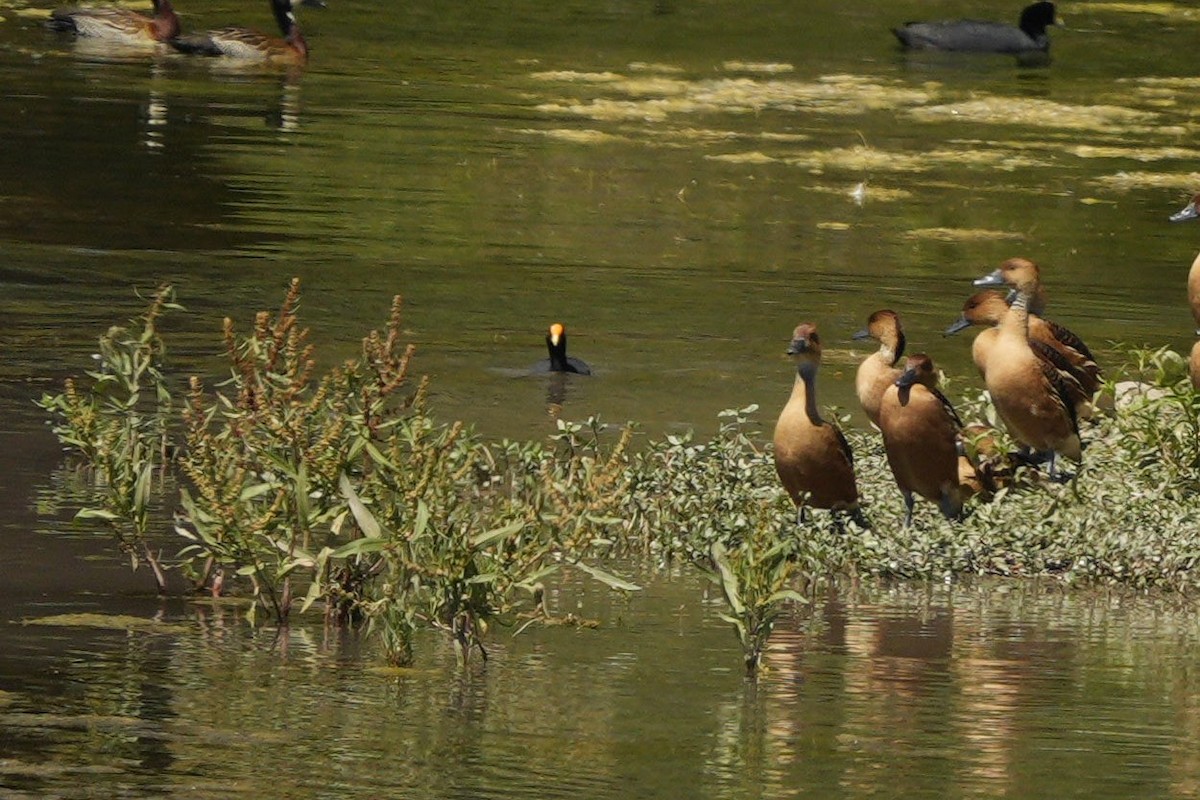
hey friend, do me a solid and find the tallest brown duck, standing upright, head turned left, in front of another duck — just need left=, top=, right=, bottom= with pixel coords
left=977, top=259, right=1082, bottom=479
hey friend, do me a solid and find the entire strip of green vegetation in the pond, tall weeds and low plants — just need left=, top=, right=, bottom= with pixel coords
left=41, top=283, right=1200, bottom=674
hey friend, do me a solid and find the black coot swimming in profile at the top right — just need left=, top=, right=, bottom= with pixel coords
left=892, top=2, right=1055, bottom=53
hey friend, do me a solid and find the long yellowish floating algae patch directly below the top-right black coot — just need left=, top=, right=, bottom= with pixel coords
left=908, top=97, right=1163, bottom=133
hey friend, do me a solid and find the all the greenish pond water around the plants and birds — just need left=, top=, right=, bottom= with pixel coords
left=0, top=0, right=1200, bottom=798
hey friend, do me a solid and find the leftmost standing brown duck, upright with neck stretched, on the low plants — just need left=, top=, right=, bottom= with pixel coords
left=775, top=323, right=862, bottom=522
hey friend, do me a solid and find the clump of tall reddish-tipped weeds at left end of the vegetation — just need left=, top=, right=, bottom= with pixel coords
left=42, top=281, right=637, bottom=663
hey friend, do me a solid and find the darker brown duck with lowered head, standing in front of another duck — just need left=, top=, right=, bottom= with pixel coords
left=880, top=353, right=976, bottom=527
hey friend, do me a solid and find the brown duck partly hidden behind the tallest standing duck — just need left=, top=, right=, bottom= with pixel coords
left=946, top=290, right=1099, bottom=419
